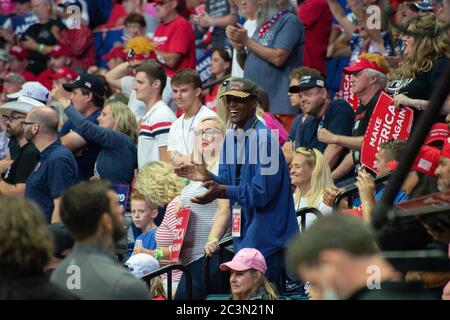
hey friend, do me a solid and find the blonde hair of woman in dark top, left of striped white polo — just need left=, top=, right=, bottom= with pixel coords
left=105, top=100, right=138, bottom=141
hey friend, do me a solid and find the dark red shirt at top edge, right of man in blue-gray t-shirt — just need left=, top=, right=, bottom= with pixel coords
left=298, top=0, right=332, bottom=75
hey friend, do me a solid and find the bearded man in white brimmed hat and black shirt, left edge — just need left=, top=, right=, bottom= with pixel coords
left=0, top=100, right=39, bottom=196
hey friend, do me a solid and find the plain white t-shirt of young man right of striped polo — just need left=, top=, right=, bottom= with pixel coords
left=167, top=106, right=216, bottom=155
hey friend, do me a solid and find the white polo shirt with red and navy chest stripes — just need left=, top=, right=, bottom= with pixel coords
left=138, top=100, right=177, bottom=169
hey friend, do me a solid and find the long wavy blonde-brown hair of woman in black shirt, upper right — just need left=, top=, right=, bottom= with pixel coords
left=395, top=13, right=449, bottom=79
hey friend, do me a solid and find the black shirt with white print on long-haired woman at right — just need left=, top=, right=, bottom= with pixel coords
left=386, top=59, right=449, bottom=124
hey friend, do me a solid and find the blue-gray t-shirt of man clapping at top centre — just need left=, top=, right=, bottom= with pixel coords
left=244, top=13, right=304, bottom=114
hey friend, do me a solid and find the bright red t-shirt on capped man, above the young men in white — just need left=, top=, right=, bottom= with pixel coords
left=153, top=16, right=196, bottom=78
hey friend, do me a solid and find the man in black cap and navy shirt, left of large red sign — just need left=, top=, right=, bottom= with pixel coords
left=291, top=76, right=355, bottom=169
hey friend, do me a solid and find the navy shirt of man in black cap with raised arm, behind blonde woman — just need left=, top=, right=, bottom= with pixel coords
left=59, top=109, right=101, bottom=181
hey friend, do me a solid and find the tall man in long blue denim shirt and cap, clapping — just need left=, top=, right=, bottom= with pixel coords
left=175, top=78, right=298, bottom=296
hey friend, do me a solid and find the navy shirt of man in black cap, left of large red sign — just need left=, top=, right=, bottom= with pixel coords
left=295, top=99, right=355, bottom=153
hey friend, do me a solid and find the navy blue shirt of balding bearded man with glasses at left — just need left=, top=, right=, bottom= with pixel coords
left=25, top=140, right=78, bottom=222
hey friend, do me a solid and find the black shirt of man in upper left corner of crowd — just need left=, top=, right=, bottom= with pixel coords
left=24, top=19, right=65, bottom=75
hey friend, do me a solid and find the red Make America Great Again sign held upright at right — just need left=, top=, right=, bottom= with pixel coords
left=361, top=92, right=414, bottom=172
